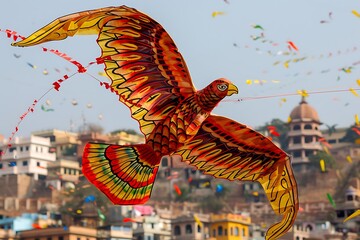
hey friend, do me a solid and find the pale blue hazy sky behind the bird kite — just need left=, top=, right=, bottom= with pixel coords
left=0, top=0, right=360, bottom=137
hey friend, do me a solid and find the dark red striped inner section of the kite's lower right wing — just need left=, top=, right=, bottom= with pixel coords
left=175, top=115, right=288, bottom=181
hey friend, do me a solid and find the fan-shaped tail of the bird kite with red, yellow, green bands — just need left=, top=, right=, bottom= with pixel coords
left=82, top=143, right=160, bottom=205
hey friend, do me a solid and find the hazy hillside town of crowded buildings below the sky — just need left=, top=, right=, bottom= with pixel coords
left=0, top=97, right=360, bottom=240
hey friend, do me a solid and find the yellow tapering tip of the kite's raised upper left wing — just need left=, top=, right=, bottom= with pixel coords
left=12, top=6, right=135, bottom=47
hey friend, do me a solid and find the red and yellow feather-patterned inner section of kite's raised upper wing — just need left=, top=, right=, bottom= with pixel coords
left=97, top=8, right=195, bottom=136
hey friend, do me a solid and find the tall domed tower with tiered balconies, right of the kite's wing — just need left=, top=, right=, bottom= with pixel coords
left=287, top=97, right=323, bottom=171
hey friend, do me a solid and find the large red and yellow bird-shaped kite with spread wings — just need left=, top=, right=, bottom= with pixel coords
left=13, top=6, right=299, bottom=239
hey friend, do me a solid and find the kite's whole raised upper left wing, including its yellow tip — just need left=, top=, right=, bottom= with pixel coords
left=13, top=6, right=195, bottom=136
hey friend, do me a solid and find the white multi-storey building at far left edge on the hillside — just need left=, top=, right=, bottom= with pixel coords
left=0, top=136, right=56, bottom=180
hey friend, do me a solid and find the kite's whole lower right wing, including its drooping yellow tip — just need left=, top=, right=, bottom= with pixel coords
left=174, top=115, right=299, bottom=239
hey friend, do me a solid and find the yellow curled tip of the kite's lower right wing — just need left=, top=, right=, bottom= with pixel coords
left=258, top=159, right=299, bottom=240
